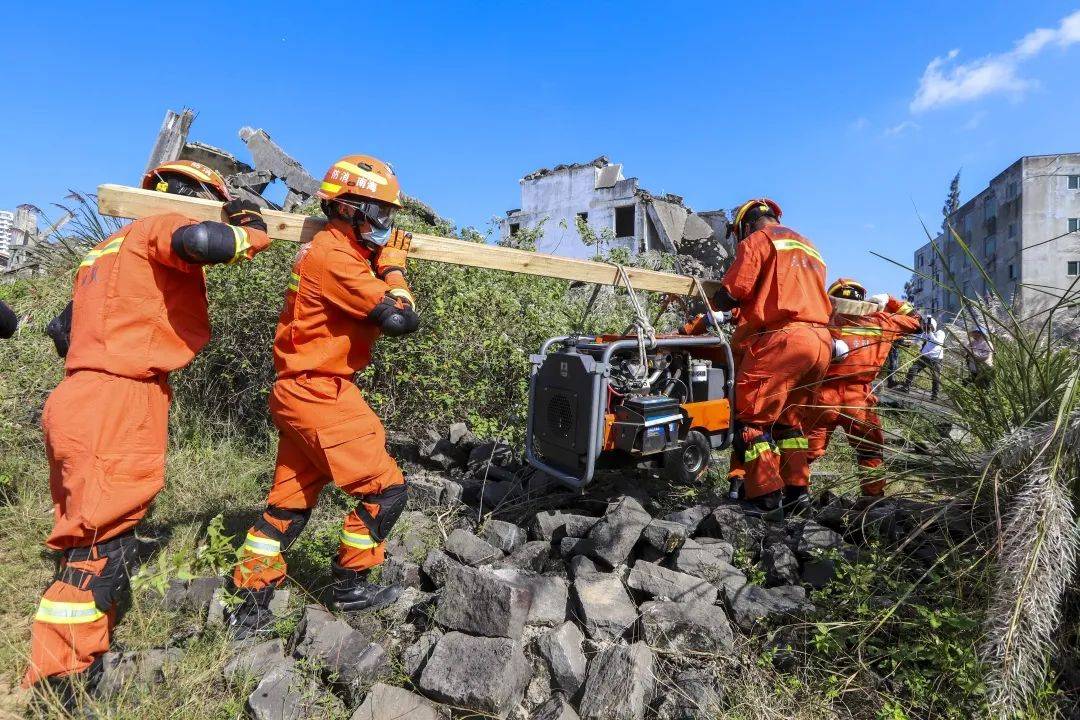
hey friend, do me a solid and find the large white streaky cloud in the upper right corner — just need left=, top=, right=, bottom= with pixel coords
left=910, top=10, right=1080, bottom=112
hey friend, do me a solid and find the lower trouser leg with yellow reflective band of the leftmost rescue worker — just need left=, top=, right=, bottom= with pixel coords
left=23, top=580, right=112, bottom=687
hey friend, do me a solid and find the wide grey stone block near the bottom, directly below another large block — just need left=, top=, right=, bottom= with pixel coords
left=419, top=633, right=531, bottom=718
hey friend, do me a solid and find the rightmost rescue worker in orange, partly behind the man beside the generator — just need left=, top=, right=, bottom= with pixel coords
left=802, top=277, right=922, bottom=497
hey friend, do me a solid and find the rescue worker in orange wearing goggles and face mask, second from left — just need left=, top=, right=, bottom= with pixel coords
left=230, top=155, right=419, bottom=639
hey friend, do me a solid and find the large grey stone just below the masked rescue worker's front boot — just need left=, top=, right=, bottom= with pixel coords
left=293, top=604, right=387, bottom=693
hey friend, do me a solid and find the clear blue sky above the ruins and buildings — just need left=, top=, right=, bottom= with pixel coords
left=0, top=0, right=1080, bottom=291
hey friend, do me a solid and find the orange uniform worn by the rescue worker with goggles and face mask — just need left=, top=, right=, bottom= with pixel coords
left=233, top=219, right=411, bottom=589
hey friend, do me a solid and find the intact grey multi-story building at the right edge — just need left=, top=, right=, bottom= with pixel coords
left=910, top=152, right=1080, bottom=320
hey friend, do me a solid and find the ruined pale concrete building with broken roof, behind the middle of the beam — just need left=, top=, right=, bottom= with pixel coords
left=499, top=155, right=730, bottom=269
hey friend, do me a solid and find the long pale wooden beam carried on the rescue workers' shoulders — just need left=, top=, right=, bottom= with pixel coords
left=97, top=185, right=719, bottom=295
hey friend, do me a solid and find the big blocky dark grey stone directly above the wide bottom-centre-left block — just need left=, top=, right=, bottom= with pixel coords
left=435, top=566, right=532, bottom=639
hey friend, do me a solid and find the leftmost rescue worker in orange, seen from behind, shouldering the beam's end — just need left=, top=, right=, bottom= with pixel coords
left=24, top=161, right=270, bottom=690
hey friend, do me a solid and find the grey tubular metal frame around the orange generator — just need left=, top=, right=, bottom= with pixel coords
left=525, top=335, right=734, bottom=490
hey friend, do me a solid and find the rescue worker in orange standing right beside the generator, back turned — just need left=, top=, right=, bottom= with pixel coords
left=714, top=198, right=832, bottom=515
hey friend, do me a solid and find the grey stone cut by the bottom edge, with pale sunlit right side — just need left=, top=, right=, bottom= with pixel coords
left=579, top=642, right=656, bottom=720
